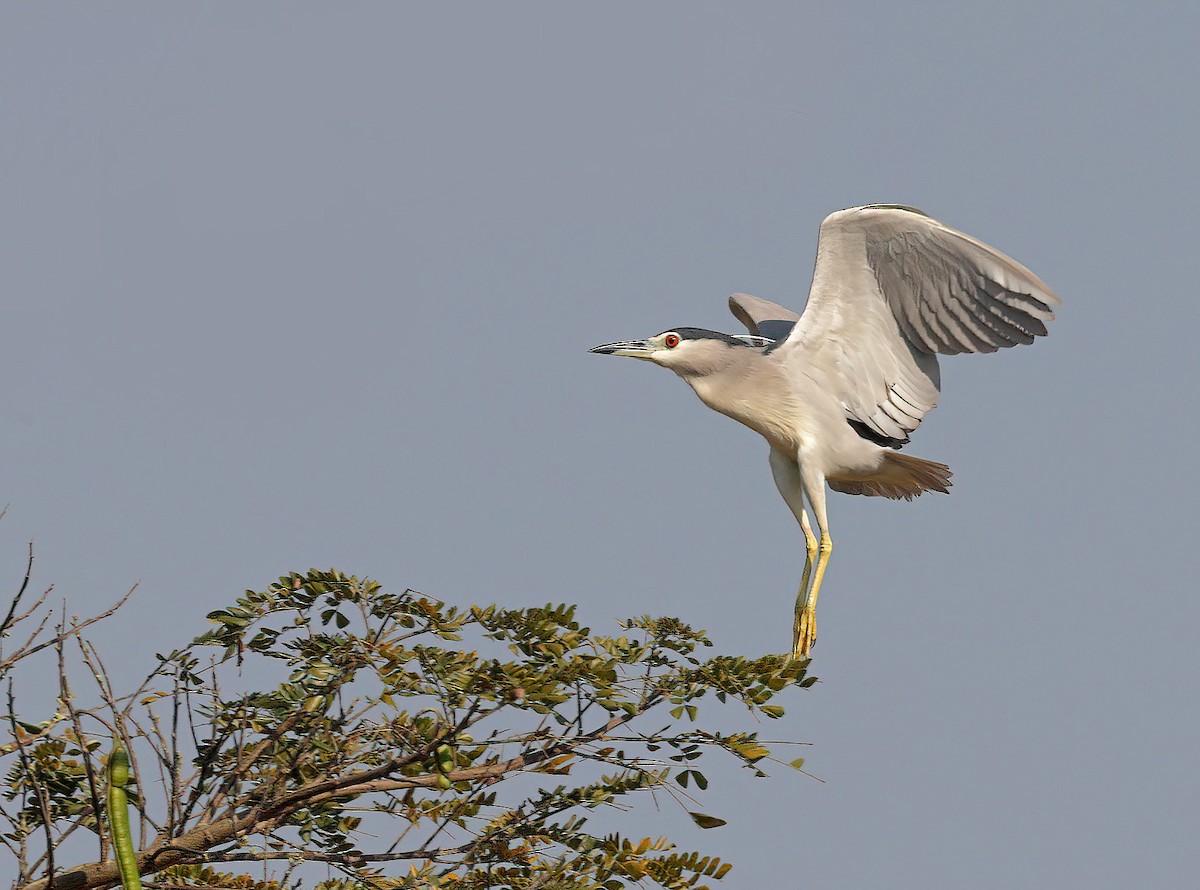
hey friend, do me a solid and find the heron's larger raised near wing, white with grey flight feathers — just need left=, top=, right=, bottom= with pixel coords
left=772, top=204, right=1061, bottom=445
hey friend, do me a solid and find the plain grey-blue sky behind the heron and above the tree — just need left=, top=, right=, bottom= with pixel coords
left=0, top=2, right=1200, bottom=890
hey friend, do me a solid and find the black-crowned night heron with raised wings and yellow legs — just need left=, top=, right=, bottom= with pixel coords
left=592, top=204, right=1060, bottom=657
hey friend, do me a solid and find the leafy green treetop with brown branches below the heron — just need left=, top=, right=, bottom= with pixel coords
left=0, top=556, right=814, bottom=890
